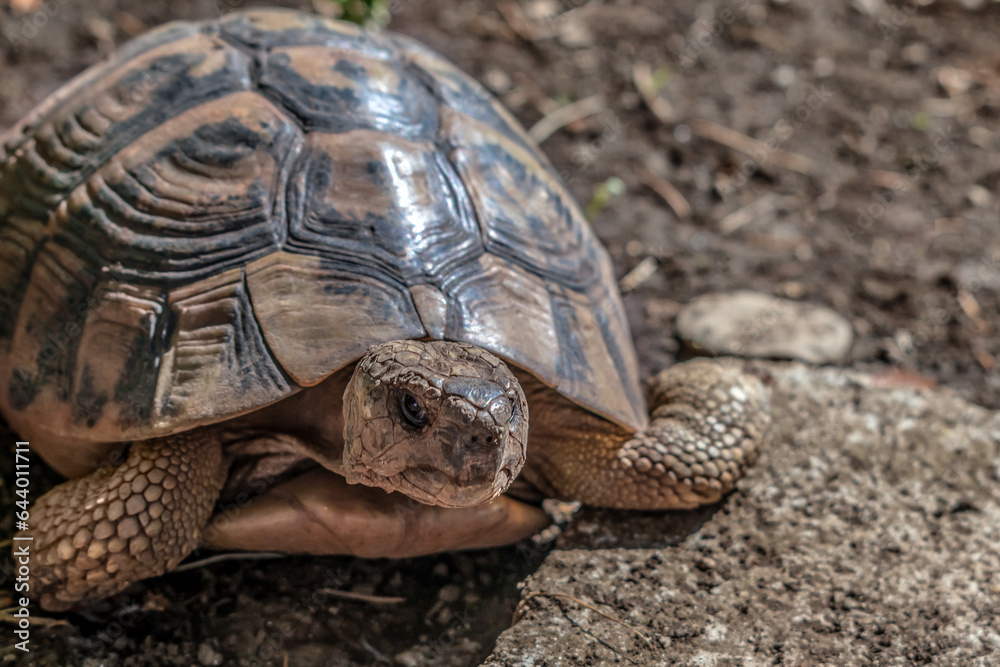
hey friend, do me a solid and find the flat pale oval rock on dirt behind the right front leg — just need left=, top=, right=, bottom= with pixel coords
left=677, top=291, right=853, bottom=364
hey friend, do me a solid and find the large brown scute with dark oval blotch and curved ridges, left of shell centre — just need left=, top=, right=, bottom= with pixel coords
left=49, top=93, right=300, bottom=284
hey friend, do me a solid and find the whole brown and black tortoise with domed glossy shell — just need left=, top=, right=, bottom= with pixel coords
left=0, top=10, right=769, bottom=610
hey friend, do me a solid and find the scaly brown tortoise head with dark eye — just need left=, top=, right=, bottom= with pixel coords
left=344, top=340, right=528, bottom=507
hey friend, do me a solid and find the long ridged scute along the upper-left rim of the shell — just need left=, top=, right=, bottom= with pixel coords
left=0, top=30, right=252, bottom=345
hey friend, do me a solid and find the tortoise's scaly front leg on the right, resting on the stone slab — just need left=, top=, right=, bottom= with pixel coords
left=525, top=359, right=771, bottom=509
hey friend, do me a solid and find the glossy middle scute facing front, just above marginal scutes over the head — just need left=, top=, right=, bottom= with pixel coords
left=287, top=130, right=484, bottom=286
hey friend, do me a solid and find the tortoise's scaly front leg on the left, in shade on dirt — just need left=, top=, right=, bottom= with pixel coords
left=19, top=429, right=226, bottom=611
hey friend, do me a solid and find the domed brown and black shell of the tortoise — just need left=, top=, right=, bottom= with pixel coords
left=0, top=10, right=647, bottom=442
